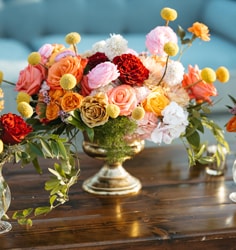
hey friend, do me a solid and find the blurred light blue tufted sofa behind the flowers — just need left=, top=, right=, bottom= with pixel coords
left=0, top=0, right=236, bottom=112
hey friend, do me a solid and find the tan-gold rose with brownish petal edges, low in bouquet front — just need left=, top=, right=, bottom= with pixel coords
left=80, top=93, right=109, bottom=128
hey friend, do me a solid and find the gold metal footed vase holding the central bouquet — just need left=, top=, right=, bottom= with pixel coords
left=82, top=140, right=144, bottom=196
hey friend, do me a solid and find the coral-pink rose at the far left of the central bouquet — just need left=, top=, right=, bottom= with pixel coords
left=16, top=65, right=45, bottom=95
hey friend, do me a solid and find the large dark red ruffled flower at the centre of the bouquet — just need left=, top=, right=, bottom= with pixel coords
left=113, top=54, right=149, bottom=86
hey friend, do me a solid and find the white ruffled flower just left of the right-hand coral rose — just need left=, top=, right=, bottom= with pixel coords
left=162, top=61, right=184, bottom=86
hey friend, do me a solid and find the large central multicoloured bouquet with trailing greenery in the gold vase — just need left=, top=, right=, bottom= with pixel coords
left=1, top=8, right=229, bottom=227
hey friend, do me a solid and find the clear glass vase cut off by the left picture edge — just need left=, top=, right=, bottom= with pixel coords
left=0, top=163, right=12, bottom=234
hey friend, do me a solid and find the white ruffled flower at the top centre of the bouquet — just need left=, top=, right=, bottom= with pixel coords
left=104, top=34, right=128, bottom=61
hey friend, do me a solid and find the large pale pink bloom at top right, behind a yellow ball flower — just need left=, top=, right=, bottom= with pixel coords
left=146, top=26, right=178, bottom=56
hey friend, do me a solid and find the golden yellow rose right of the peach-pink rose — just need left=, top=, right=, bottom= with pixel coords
left=143, top=87, right=170, bottom=116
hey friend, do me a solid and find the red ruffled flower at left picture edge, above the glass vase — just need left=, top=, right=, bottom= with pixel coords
left=0, top=113, right=33, bottom=145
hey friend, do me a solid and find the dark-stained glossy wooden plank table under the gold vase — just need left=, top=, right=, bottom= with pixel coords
left=0, top=146, right=236, bottom=250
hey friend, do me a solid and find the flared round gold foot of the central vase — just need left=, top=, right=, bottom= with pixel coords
left=83, top=164, right=142, bottom=196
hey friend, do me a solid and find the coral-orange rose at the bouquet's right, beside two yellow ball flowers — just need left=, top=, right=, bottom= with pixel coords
left=182, top=65, right=217, bottom=103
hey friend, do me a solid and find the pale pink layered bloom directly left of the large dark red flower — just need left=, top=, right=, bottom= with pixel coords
left=88, top=62, right=120, bottom=89
